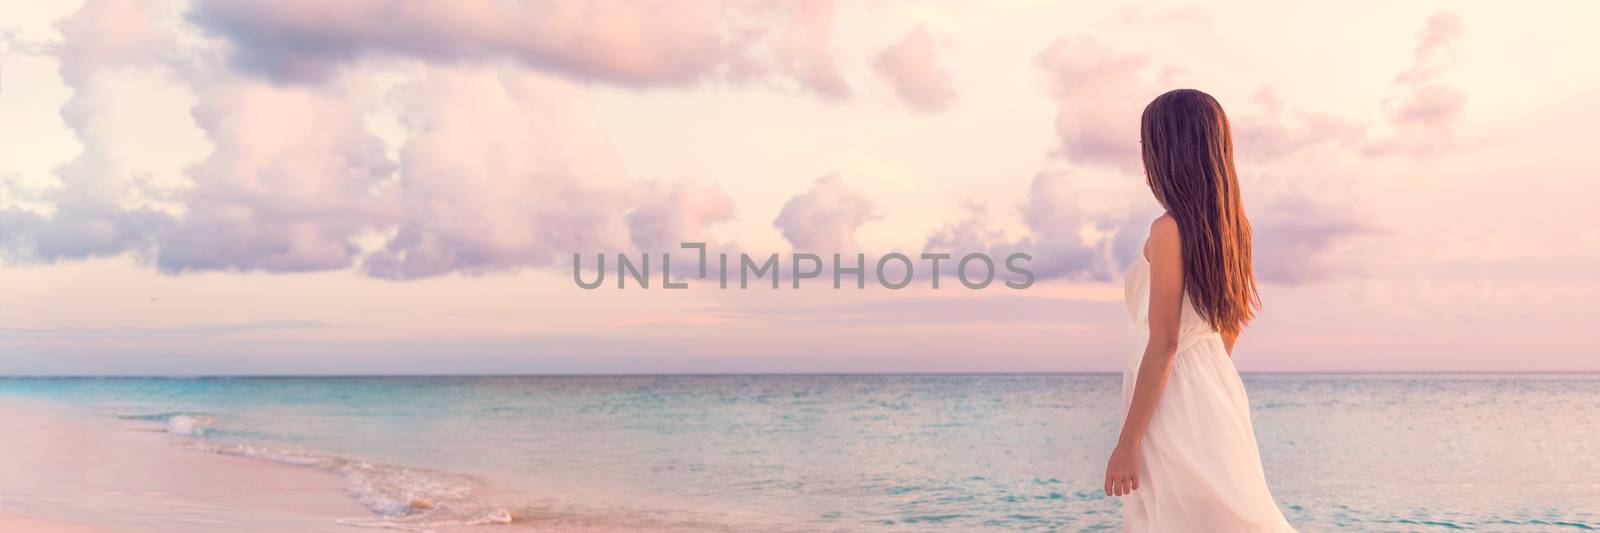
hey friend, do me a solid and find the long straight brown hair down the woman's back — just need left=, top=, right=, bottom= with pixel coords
left=1139, top=90, right=1261, bottom=335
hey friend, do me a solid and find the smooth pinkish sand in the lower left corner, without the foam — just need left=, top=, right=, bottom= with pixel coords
left=0, top=397, right=371, bottom=533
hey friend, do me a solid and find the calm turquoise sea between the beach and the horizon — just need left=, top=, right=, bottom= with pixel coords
left=0, top=375, right=1600, bottom=531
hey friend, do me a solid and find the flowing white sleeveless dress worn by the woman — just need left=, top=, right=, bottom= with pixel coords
left=1122, top=253, right=1294, bottom=531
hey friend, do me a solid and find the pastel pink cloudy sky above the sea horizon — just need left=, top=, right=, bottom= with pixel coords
left=0, top=0, right=1600, bottom=375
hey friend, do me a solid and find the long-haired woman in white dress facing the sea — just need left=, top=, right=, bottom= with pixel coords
left=1106, top=90, right=1293, bottom=531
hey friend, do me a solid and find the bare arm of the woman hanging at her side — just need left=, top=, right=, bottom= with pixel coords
left=1106, top=216, right=1184, bottom=496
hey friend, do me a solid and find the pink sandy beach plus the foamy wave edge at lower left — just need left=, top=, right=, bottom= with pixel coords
left=0, top=394, right=731, bottom=533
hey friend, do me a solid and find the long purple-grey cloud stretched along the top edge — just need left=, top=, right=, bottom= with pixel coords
left=189, top=0, right=848, bottom=98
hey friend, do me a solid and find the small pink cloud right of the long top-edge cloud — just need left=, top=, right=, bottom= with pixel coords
left=872, top=24, right=955, bottom=114
